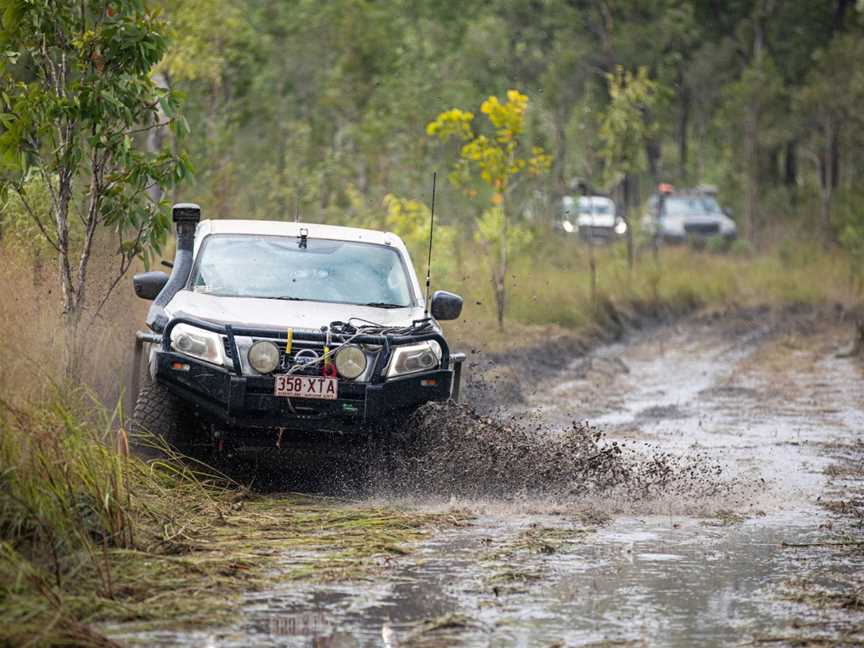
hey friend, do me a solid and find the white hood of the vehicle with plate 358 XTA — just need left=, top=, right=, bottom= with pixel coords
left=165, top=290, right=424, bottom=331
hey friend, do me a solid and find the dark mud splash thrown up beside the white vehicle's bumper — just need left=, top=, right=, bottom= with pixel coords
left=369, top=403, right=740, bottom=504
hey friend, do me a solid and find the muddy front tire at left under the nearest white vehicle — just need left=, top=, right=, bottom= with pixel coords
left=129, top=382, right=200, bottom=459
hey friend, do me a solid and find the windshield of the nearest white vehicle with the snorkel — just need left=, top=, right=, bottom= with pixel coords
left=192, top=234, right=413, bottom=307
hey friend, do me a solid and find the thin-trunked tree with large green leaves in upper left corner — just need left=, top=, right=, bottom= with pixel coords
left=0, top=0, right=190, bottom=321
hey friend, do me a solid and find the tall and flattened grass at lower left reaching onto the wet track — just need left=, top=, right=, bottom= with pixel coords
left=0, top=392, right=466, bottom=645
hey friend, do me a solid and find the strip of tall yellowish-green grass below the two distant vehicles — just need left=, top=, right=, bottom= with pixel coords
left=438, top=238, right=860, bottom=350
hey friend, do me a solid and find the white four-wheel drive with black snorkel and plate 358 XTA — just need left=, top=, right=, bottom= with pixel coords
left=132, top=204, right=464, bottom=450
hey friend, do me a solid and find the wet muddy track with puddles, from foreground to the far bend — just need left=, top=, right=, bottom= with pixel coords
left=112, top=312, right=864, bottom=646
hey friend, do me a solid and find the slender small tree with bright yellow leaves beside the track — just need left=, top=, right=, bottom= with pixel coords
left=426, top=90, right=552, bottom=326
